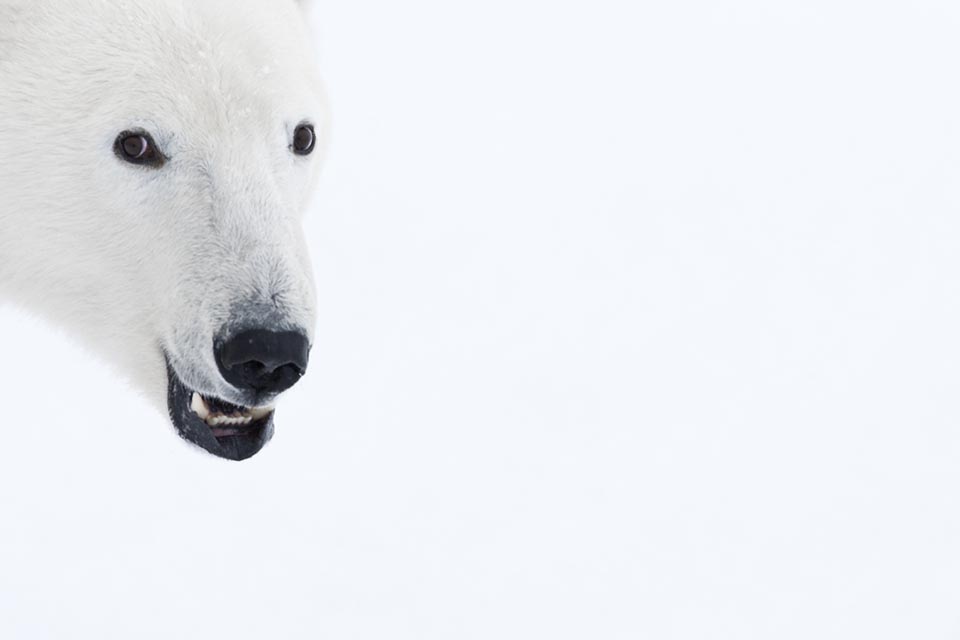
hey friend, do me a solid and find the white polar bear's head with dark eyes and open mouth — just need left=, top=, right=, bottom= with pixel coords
left=0, top=0, right=329, bottom=460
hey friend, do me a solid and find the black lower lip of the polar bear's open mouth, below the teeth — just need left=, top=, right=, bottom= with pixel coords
left=167, top=361, right=273, bottom=461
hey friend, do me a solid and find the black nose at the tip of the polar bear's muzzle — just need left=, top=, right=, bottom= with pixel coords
left=214, top=329, right=310, bottom=394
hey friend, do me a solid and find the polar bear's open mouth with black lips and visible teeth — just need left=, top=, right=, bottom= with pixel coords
left=167, top=363, right=273, bottom=460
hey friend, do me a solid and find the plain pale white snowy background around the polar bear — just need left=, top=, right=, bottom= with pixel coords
left=0, top=0, right=960, bottom=640
